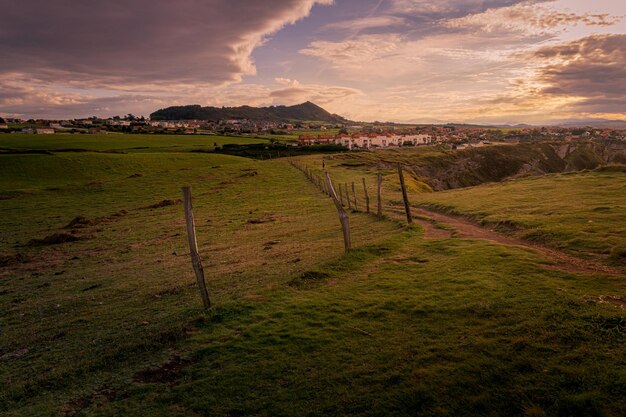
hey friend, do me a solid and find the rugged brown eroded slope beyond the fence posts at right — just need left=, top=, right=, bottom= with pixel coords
left=335, top=142, right=626, bottom=191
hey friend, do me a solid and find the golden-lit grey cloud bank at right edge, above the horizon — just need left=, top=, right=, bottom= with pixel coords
left=468, top=34, right=626, bottom=122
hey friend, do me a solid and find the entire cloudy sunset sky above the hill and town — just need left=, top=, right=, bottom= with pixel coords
left=0, top=0, right=626, bottom=124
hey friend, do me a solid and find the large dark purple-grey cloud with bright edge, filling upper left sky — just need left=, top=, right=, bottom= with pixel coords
left=0, top=0, right=332, bottom=88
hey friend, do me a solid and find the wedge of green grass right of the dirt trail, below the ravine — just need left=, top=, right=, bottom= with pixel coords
left=415, top=169, right=626, bottom=269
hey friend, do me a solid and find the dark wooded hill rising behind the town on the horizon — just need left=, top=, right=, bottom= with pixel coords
left=150, top=101, right=348, bottom=123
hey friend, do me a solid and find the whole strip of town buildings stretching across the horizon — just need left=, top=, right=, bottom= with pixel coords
left=0, top=115, right=626, bottom=145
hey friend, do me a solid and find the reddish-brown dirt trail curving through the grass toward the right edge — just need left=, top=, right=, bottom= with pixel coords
left=415, top=208, right=625, bottom=275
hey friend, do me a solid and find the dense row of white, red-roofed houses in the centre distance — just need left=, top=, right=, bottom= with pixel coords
left=298, top=133, right=434, bottom=149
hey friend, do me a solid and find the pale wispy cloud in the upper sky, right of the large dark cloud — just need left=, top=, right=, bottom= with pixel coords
left=300, top=26, right=541, bottom=83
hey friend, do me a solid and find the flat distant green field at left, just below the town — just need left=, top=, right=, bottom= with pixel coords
left=0, top=133, right=264, bottom=152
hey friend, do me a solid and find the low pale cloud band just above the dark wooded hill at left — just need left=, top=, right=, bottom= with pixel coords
left=0, top=74, right=363, bottom=119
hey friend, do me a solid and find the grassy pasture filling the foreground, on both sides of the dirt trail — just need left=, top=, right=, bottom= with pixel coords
left=0, top=136, right=626, bottom=416
